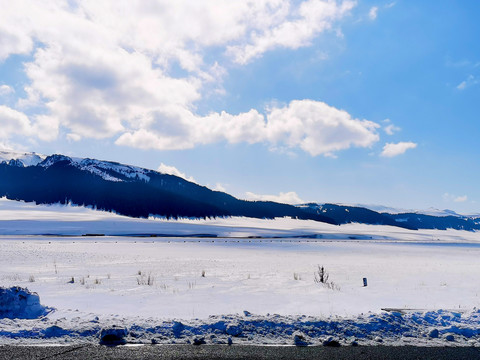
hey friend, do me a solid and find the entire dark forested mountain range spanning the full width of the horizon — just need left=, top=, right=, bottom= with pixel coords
left=0, top=151, right=480, bottom=231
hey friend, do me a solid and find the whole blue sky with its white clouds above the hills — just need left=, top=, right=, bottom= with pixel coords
left=0, top=0, right=480, bottom=213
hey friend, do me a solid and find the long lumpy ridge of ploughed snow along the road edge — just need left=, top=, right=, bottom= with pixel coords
left=0, top=309, right=480, bottom=347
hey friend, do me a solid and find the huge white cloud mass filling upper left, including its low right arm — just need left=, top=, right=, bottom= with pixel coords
left=0, top=0, right=364, bottom=156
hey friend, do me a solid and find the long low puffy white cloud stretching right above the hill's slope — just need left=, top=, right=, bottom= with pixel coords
left=116, top=100, right=379, bottom=156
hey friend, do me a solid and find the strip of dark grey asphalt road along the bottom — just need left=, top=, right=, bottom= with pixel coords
left=0, top=345, right=480, bottom=360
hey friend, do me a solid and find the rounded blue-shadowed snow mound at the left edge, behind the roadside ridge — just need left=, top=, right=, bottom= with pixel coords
left=0, top=286, right=48, bottom=319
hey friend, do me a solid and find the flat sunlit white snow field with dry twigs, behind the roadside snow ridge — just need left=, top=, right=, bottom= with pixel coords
left=0, top=238, right=480, bottom=319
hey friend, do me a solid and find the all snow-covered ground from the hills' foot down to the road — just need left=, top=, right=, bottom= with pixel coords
left=0, top=199, right=480, bottom=346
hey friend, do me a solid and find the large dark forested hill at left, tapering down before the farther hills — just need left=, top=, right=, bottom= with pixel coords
left=0, top=152, right=336, bottom=224
